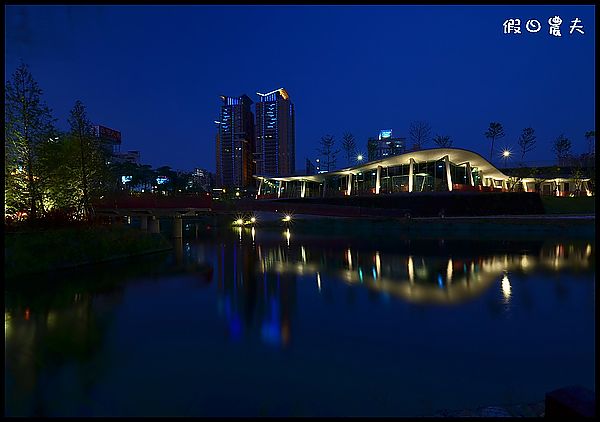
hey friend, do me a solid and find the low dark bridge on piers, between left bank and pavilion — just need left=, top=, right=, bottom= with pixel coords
left=93, top=193, right=212, bottom=238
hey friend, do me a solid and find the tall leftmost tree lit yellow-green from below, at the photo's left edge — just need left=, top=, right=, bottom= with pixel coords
left=4, top=63, right=55, bottom=221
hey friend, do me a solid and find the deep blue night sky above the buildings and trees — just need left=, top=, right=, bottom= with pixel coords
left=5, top=5, right=595, bottom=171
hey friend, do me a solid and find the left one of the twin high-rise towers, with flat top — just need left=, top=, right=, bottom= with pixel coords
left=216, top=94, right=255, bottom=188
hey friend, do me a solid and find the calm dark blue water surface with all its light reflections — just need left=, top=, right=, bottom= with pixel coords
left=5, top=226, right=595, bottom=416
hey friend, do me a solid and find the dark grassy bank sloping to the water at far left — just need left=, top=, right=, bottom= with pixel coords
left=4, top=226, right=172, bottom=278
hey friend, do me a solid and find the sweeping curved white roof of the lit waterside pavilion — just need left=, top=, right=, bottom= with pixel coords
left=254, top=148, right=509, bottom=183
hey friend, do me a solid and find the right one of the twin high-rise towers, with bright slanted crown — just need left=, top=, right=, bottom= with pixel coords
left=255, top=88, right=296, bottom=176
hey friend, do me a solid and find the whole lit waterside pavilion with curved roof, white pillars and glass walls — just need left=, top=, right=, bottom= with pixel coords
left=255, top=148, right=589, bottom=198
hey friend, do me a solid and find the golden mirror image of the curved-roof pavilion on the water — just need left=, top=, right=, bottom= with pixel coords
left=255, top=236, right=593, bottom=304
